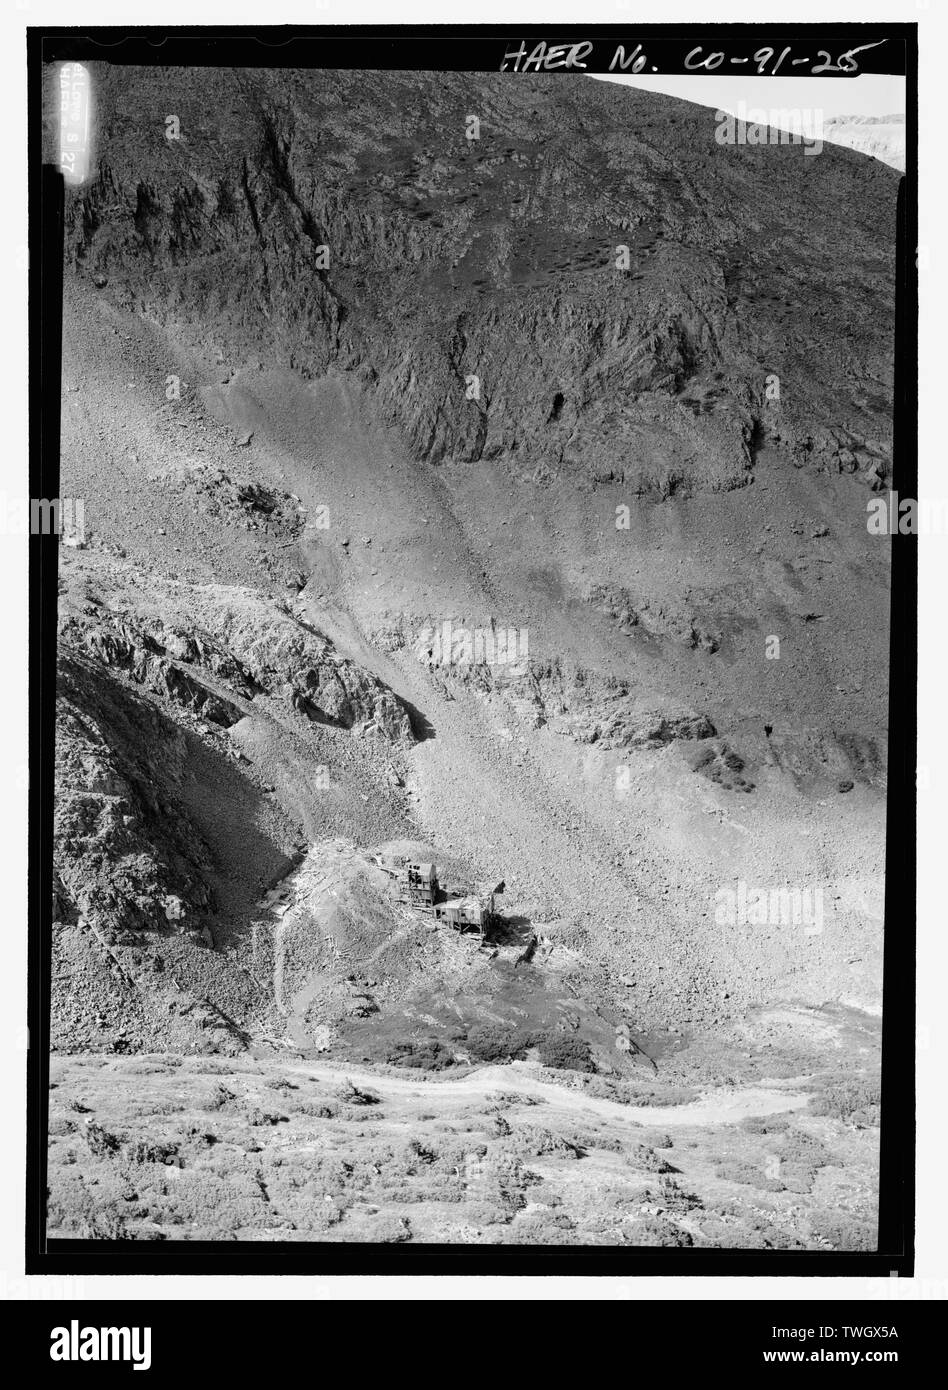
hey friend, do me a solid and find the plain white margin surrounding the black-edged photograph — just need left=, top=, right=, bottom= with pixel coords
left=0, top=0, right=948, bottom=1301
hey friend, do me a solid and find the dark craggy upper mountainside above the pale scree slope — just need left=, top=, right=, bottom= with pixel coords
left=70, top=68, right=895, bottom=495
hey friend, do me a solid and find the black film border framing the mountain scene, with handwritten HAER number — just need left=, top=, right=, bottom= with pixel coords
left=25, top=22, right=919, bottom=1277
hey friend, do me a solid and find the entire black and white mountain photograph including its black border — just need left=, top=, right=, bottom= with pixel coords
left=16, top=11, right=922, bottom=1295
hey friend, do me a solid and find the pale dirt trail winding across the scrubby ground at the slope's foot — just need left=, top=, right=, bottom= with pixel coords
left=289, top=1062, right=809, bottom=1126
